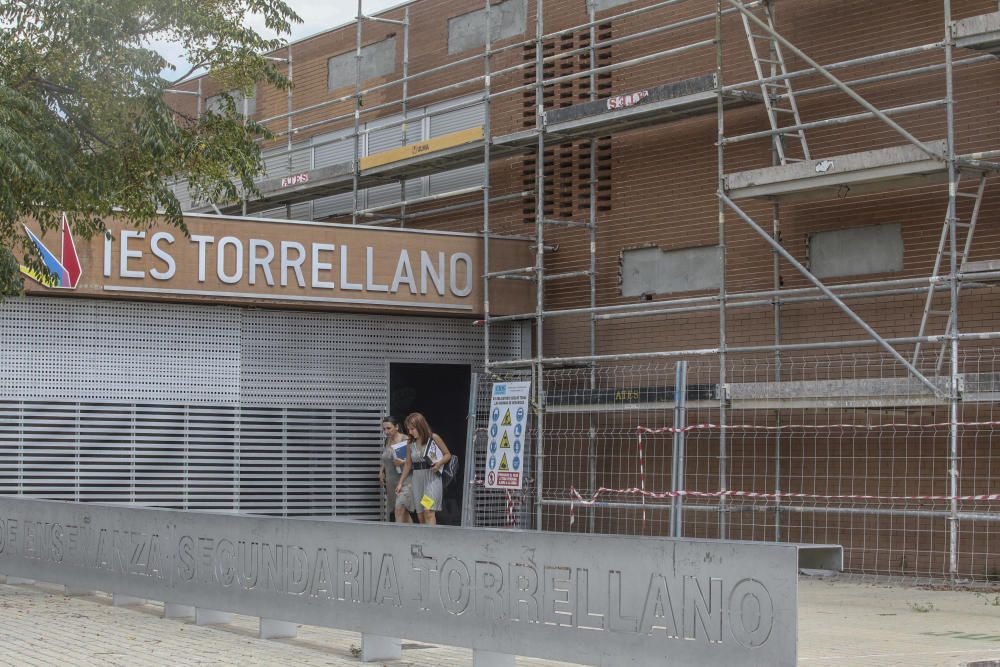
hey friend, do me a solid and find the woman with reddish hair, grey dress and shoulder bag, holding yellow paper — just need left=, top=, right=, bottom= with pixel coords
left=396, top=412, right=451, bottom=526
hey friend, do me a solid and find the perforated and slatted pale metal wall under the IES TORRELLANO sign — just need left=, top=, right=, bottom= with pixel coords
left=0, top=298, right=520, bottom=519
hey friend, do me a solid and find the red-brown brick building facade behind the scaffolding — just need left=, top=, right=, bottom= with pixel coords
left=166, top=0, right=1000, bottom=578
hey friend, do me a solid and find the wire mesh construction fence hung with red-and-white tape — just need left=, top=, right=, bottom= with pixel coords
left=474, top=350, right=1000, bottom=583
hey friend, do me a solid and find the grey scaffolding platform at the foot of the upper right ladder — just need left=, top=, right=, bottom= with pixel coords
left=725, top=139, right=948, bottom=200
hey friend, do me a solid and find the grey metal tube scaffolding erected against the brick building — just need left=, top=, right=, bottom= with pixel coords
left=174, top=0, right=1000, bottom=578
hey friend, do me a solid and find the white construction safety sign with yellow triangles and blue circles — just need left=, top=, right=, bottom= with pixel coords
left=484, top=382, right=531, bottom=489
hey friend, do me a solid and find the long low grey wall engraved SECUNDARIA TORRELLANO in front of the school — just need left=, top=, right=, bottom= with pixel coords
left=0, top=500, right=796, bottom=665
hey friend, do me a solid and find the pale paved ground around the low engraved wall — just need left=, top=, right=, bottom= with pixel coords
left=0, top=577, right=1000, bottom=667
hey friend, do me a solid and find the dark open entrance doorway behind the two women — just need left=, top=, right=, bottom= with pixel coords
left=389, top=363, right=472, bottom=526
